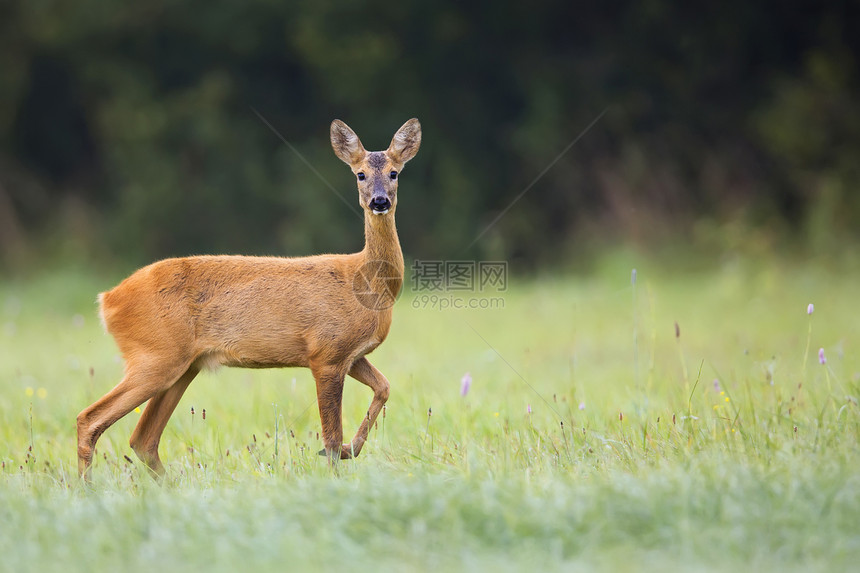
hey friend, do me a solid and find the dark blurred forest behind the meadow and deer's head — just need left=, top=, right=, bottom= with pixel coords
left=0, top=0, right=860, bottom=270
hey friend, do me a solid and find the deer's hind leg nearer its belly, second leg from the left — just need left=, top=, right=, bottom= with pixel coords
left=129, top=366, right=200, bottom=475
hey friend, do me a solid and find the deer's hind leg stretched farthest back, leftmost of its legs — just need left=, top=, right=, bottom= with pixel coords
left=77, top=357, right=189, bottom=479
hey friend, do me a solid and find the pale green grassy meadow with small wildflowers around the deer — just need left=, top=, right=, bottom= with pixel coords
left=0, top=253, right=860, bottom=572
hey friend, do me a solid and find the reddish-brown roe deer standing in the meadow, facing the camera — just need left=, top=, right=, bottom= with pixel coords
left=77, top=118, right=421, bottom=481
